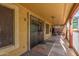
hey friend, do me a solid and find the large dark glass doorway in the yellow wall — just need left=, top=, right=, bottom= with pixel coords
left=30, top=15, right=44, bottom=49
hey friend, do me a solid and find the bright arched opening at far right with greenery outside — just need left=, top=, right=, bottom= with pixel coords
left=72, top=11, right=79, bottom=53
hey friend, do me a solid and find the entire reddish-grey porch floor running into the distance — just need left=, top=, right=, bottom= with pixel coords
left=22, top=35, right=76, bottom=56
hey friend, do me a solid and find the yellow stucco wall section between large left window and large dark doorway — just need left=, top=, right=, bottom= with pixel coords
left=3, top=4, right=27, bottom=55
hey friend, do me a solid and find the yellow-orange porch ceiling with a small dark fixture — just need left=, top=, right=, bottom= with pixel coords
left=21, top=3, right=73, bottom=25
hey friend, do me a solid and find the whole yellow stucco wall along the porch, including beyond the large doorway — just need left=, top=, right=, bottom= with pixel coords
left=2, top=4, right=51, bottom=55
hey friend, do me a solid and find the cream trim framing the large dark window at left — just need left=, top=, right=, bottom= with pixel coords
left=0, top=4, right=19, bottom=55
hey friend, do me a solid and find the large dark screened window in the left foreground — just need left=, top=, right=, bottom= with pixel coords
left=0, top=5, right=14, bottom=48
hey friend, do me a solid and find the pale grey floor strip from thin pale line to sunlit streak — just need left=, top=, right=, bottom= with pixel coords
left=49, top=36, right=67, bottom=56
